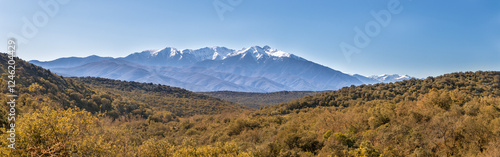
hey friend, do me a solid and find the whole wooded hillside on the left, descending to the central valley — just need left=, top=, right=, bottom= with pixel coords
left=0, top=53, right=248, bottom=122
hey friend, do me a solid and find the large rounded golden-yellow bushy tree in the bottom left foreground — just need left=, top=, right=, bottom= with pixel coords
left=5, top=106, right=110, bottom=156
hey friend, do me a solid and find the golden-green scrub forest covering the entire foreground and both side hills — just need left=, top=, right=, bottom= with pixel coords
left=0, top=53, right=500, bottom=156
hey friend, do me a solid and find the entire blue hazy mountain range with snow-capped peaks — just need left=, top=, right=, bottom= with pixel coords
left=30, top=46, right=411, bottom=92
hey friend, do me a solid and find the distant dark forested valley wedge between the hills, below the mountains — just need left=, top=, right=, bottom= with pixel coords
left=200, top=91, right=321, bottom=109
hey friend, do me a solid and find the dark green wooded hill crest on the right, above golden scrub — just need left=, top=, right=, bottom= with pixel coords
left=276, top=71, right=500, bottom=113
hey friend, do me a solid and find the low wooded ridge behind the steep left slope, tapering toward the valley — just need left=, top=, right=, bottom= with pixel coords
left=71, top=77, right=250, bottom=116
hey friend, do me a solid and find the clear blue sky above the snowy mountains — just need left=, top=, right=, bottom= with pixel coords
left=0, top=0, right=500, bottom=77
